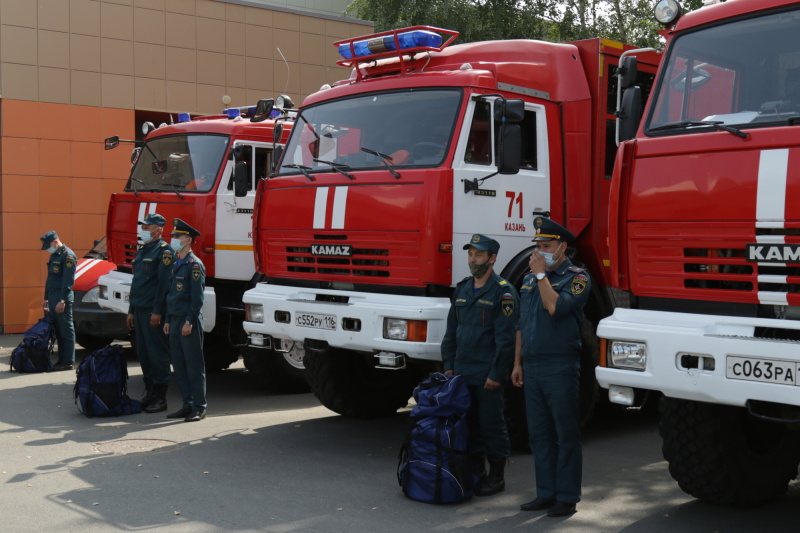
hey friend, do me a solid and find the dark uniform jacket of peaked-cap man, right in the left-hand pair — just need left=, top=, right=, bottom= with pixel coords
left=166, top=251, right=206, bottom=325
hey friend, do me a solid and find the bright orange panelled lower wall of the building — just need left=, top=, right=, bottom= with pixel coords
left=0, top=99, right=134, bottom=333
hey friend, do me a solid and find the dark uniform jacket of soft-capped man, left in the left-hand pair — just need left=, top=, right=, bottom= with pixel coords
left=128, top=239, right=173, bottom=315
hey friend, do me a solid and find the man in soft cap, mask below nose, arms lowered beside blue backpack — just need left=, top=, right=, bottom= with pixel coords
left=442, top=234, right=519, bottom=496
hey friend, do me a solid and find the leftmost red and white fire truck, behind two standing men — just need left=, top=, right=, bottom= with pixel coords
left=98, top=102, right=305, bottom=389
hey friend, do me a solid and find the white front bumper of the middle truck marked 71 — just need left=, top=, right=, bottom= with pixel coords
left=243, top=283, right=450, bottom=361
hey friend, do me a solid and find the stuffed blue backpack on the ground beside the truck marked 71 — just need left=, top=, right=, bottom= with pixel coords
left=397, top=373, right=476, bottom=503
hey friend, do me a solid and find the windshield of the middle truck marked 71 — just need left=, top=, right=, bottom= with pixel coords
left=279, top=89, right=462, bottom=175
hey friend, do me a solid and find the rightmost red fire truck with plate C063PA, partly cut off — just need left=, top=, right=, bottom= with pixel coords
left=597, top=0, right=800, bottom=505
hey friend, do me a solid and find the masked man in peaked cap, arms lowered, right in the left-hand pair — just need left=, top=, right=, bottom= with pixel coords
left=164, top=218, right=206, bottom=422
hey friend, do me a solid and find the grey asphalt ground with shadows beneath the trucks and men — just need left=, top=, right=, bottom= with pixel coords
left=0, top=335, right=800, bottom=533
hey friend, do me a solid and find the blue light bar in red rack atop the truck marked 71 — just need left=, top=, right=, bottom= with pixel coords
left=333, top=26, right=459, bottom=78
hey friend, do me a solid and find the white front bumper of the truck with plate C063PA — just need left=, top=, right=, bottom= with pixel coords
left=595, top=309, right=800, bottom=406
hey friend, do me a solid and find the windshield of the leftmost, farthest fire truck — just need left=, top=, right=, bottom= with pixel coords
left=125, top=135, right=230, bottom=192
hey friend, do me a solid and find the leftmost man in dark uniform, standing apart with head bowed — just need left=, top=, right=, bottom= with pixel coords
left=39, top=231, right=78, bottom=370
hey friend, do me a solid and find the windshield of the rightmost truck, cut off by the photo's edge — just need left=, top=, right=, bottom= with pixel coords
left=645, top=8, right=800, bottom=134
